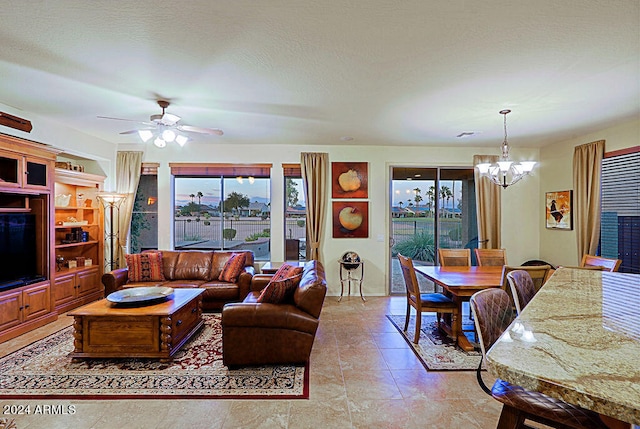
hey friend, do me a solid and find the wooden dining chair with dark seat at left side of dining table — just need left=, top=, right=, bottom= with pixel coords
left=398, top=254, right=458, bottom=344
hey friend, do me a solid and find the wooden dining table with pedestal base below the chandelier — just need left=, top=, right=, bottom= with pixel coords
left=414, top=265, right=503, bottom=351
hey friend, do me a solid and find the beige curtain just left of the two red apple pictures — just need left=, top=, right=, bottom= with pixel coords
left=300, top=152, right=329, bottom=261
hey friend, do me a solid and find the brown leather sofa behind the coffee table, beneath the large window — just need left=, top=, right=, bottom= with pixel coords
left=102, top=250, right=255, bottom=311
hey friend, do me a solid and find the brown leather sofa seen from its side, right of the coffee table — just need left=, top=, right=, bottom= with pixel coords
left=222, top=261, right=327, bottom=367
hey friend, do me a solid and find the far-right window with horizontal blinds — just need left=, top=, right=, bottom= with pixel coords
left=600, top=146, right=640, bottom=274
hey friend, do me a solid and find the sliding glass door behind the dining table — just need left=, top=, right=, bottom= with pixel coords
left=389, top=167, right=478, bottom=293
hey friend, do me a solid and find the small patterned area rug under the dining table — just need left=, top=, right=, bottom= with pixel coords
left=387, top=313, right=482, bottom=371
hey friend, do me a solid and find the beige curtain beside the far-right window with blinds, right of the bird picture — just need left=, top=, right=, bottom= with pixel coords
left=573, top=140, right=604, bottom=262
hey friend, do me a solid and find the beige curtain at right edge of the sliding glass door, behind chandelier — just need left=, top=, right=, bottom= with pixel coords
left=473, top=155, right=502, bottom=249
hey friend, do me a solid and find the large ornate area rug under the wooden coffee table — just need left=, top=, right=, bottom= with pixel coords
left=0, top=314, right=309, bottom=399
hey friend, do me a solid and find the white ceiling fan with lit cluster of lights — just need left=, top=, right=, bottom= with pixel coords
left=98, top=100, right=223, bottom=148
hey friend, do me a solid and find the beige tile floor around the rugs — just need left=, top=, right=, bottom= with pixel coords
left=0, top=296, right=500, bottom=429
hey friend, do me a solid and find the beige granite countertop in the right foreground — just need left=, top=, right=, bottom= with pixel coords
left=487, top=268, right=640, bottom=427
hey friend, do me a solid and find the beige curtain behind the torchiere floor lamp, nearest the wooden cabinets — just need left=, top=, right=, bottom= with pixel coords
left=116, top=152, right=142, bottom=268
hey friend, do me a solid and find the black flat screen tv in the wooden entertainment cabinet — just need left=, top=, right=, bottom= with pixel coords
left=0, top=213, right=44, bottom=290
